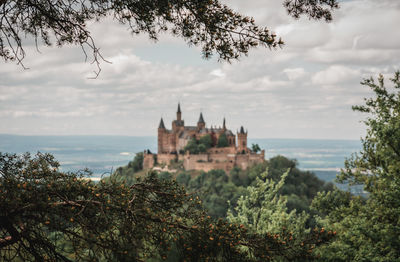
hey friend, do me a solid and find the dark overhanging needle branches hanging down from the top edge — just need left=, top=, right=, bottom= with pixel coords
left=0, top=0, right=338, bottom=71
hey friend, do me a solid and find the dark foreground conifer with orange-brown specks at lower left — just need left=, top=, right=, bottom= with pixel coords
left=0, top=153, right=329, bottom=261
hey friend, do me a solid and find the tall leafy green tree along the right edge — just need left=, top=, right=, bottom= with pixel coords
left=313, top=71, right=400, bottom=261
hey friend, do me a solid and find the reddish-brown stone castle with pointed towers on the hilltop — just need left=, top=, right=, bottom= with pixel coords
left=143, top=104, right=265, bottom=172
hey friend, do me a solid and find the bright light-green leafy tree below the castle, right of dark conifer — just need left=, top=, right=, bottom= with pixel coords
left=228, top=170, right=334, bottom=261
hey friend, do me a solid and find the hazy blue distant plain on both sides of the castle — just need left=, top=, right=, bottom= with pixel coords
left=0, top=134, right=361, bottom=181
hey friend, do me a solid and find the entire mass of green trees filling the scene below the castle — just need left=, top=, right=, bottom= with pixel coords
left=0, top=72, right=400, bottom=261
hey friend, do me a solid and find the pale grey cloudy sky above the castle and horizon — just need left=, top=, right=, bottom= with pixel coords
left=0, top=0, right=400, bottom=139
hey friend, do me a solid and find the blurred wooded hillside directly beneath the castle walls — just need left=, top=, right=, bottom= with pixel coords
left=113, top=153, right=334, bottom=218
